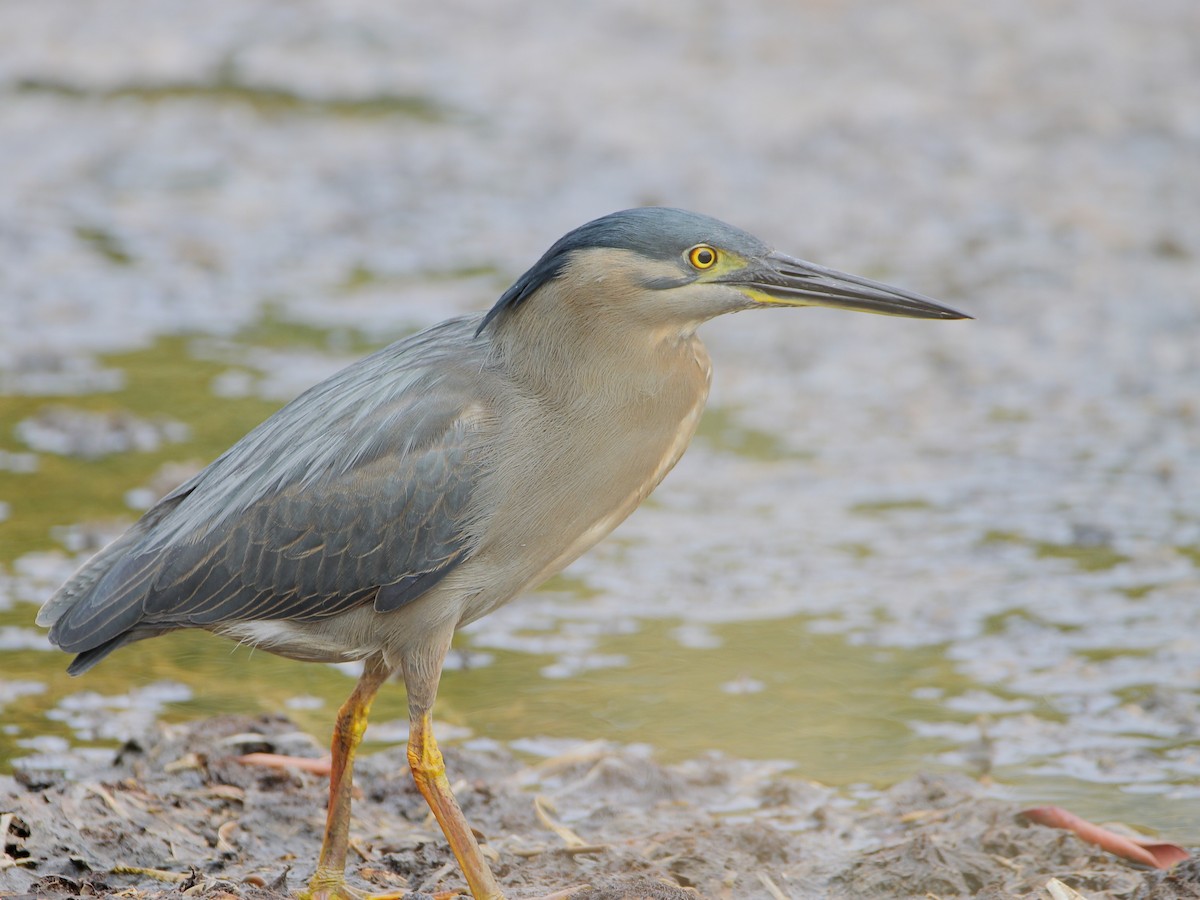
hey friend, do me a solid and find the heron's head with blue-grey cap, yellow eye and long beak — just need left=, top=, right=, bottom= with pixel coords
left=480, top=208, right=971, bottom=331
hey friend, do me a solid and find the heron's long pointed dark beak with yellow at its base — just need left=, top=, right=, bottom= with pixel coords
left=722, top=253, right=971, bottom=319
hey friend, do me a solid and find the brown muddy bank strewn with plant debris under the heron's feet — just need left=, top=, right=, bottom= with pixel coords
left=0, top=716, right=1200, bottom=900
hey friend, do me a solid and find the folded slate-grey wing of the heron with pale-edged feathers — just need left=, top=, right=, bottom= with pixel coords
left=41, top=320, right=492, bottom=671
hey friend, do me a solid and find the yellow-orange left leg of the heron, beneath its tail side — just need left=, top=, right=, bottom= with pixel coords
left=300, top=660, right=390, bottom=900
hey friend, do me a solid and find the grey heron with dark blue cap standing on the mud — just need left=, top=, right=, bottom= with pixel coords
left=37, top=209, right=968, bottom=900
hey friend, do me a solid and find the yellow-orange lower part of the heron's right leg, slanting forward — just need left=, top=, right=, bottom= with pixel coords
left=408, top=707, right=504, bottom=900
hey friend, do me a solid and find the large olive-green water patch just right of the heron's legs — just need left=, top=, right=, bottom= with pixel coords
left=439, top=619, right=972, bottom=785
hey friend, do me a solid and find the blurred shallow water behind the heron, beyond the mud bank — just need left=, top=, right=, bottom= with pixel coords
left=0, top=0, right=1200, bottom=844
